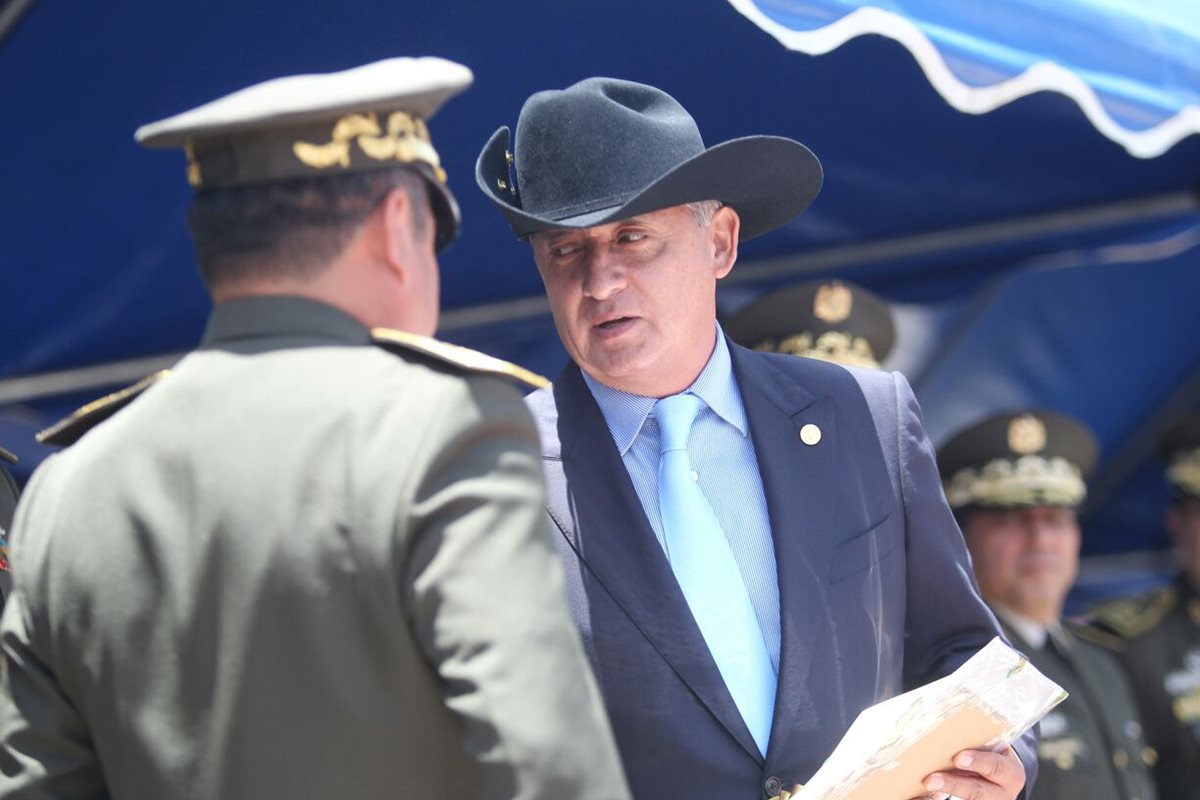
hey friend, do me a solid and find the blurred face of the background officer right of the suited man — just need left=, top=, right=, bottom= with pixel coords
left=962, top=506, right=1080, bottom=622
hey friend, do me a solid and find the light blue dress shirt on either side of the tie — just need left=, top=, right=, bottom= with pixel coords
left=583, top=325, right=780, bottom=674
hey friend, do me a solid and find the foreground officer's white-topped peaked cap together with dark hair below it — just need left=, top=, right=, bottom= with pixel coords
left=136, top=58, right=473, bottom=294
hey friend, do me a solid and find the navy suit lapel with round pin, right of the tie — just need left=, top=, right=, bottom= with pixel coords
left=730, top=343, right=838, bottom=762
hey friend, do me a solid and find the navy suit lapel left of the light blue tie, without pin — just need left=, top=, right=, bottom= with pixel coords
left=535, top=365, right=762, bottom=762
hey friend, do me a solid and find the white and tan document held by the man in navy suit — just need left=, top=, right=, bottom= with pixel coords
left=791, top=638, right=1067, bottom=800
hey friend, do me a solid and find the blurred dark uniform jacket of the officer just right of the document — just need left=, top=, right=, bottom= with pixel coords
left=1003, top=625, right=1156, bottom=800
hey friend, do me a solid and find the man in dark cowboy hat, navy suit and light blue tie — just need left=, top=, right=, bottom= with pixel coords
left=476, top=78, right=1034, bottom=800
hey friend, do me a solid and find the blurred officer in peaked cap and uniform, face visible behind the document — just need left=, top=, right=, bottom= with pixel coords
left=937, top=410, right=1156, bottom=800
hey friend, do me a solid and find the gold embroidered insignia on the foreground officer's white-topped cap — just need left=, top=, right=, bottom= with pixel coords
left=292, top=112, right=445, bottom=184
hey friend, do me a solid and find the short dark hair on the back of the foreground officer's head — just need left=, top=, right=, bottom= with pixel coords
left=187, top=168, right=433, bottom=290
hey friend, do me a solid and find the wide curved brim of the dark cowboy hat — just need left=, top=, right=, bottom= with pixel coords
left=475, top=127, right=823, bottom=241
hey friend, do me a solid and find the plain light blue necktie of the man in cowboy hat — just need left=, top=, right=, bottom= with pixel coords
left=653, top=395, right=776, bottom=757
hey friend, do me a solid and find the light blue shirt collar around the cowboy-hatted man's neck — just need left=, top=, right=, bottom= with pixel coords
left=581, top=324, right=749, bottom=456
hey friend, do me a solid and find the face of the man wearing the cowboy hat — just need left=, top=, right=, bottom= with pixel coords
left=530, top=205, right=738, bottom=397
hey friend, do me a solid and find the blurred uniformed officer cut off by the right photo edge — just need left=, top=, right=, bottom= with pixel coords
left=1093, top=414, right=1200, bottom=800
